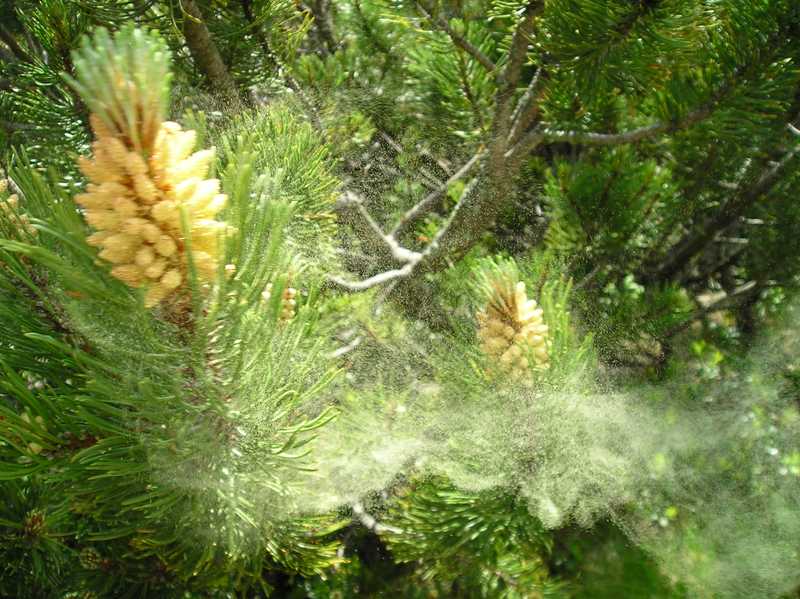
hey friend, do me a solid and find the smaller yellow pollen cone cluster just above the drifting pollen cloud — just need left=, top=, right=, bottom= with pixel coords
left=476, top=279, right=549, bottom=379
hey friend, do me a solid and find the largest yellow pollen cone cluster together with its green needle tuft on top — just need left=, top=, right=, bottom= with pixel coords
left=68, top=25, right=229, bottom=307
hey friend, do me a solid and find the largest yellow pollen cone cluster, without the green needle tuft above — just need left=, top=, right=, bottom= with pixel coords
left=75, top=115, right=227, bottom=307
